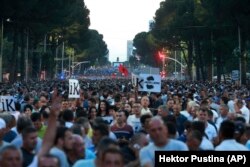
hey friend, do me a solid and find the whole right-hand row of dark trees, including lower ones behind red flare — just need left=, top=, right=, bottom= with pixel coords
left=131, top=0, right=250, bottom=84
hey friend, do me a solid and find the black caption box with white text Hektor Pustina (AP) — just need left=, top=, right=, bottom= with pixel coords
left=155, top=151, right=250, bottom=167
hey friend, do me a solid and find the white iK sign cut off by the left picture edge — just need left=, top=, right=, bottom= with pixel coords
left=0, top=96, right=16, bottom=111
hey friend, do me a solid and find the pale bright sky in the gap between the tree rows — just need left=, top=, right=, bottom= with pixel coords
left=84, top=0, right=163, bottom=62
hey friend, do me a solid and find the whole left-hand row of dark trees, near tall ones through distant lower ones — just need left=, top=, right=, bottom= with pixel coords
left=0, top=0, right=108, bottom=81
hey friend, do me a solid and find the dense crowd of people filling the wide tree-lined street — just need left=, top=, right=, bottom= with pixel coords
left=0, top=79, right=250, bottom=167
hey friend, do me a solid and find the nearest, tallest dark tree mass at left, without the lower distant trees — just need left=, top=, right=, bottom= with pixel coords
left=0, top=0, right=94, bottom=81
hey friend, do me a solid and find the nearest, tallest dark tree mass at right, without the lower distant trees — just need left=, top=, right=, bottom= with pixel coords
left=152, top=0, right=249, bottom=82
